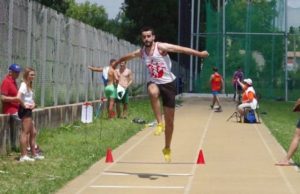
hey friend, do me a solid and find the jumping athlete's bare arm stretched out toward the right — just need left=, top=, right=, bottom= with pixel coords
left=158, top=43, right=209, bottom=58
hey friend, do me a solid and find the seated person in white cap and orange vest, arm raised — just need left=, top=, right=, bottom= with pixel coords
left=237, top=78, right=257, bottom=118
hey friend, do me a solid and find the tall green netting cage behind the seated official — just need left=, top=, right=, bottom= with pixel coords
left=191, top=0, right=300, bottom=100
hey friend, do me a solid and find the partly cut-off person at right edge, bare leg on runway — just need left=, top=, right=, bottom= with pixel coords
left=275, top=98, right=300, bottom=166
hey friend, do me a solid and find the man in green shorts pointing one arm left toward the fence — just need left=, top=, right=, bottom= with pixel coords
left=88, top=59, right=117, bottom=119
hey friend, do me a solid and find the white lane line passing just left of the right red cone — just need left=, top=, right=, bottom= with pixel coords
left=184, top=111, right=214, bottom=194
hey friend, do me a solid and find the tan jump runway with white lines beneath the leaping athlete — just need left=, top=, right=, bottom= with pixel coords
left=58, top=97, right=300, bottom=194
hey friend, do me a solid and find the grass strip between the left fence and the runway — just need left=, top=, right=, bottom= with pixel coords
left=0, top=99, right=154, bottom=194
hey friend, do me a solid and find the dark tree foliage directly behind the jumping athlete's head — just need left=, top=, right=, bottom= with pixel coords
left=122, top=0, right=178, bottom=44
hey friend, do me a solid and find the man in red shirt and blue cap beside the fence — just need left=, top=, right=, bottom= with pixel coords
left=1, top=64, right=21, bottom=115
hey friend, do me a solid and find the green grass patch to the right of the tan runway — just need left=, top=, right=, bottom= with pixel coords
left=260, top=100, right=300, bottom=164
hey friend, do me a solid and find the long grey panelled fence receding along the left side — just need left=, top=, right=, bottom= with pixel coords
left=0, top=0, right=146, bottom=107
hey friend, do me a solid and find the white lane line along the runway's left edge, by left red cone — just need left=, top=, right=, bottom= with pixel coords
left=76, top=130, right=153, bottom=193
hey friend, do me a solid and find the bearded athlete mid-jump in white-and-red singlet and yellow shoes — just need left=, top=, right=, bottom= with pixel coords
left=112, top=27, right=208, bottom=162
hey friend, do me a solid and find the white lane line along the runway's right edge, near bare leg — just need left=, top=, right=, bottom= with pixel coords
left=254, top=124, right=297, bottom=194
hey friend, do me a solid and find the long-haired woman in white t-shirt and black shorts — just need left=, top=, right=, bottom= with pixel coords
left=17, top=67, right=44, bottom=162
